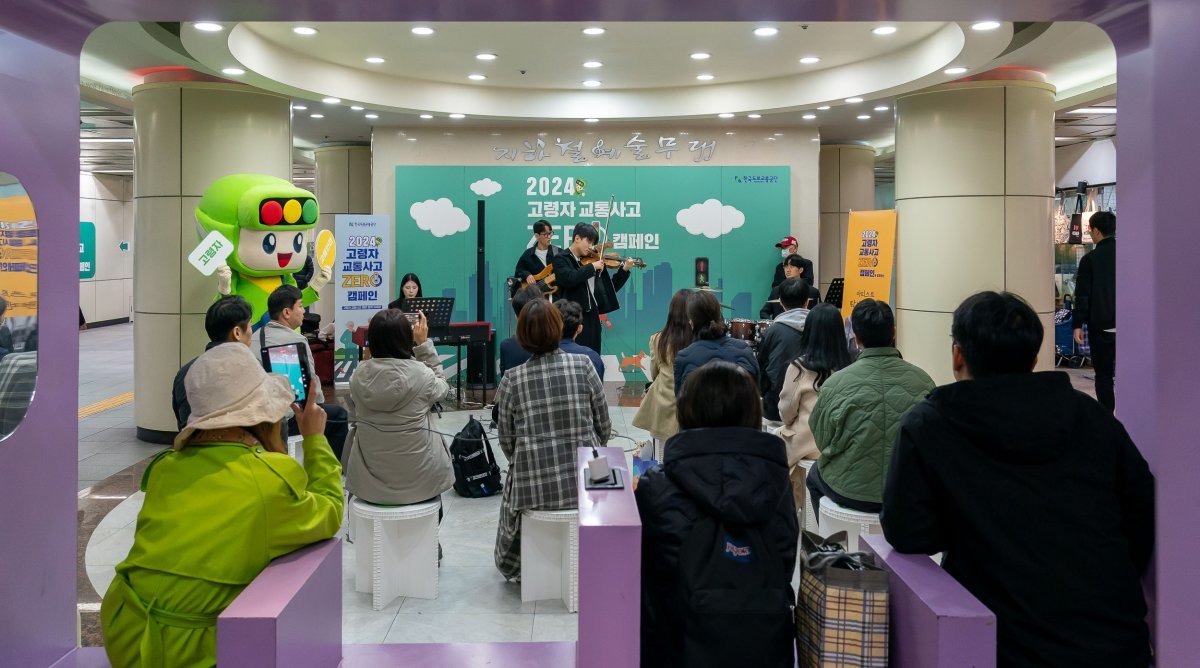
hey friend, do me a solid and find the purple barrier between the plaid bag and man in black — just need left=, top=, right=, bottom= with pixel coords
left=858, top=534, right=996, bottom=668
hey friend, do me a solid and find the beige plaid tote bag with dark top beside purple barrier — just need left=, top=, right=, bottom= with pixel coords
left=796, top=531, right=888, bottom=668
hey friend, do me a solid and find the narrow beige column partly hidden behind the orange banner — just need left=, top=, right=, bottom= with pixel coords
left=817, top=144, right=875, bottom=295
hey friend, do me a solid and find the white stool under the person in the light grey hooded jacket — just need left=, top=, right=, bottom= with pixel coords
left=350, top=499, right=442, bottom=610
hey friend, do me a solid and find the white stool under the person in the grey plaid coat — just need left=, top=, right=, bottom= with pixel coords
left=521, top=510, right=580, bottom=613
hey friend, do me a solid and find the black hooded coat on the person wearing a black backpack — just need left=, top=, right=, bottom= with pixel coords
left=634, top=427, right=800, bottom=668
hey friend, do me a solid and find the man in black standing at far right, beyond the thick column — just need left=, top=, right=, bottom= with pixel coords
left=1072, top=211, right=1117, bottom=413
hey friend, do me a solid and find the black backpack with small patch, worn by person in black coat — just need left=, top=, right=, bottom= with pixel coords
left=679, top=517, right=796, bottom=668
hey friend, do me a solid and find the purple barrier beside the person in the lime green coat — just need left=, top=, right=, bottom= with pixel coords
left=217, top=538, right=342, bottom=668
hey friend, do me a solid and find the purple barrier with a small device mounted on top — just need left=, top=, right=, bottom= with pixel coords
left=576, top=447, right=642, bottom=668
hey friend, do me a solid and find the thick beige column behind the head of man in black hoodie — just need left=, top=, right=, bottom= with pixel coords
left=893, top=71, right=1055, bottom=384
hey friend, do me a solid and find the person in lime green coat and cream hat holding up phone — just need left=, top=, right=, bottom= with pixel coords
left=100, top=343, right=343, bottom=668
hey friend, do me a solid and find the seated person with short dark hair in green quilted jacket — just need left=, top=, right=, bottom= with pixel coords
left=805, top=299, right=934, bottom=512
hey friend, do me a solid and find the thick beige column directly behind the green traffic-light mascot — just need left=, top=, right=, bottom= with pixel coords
left=133, top=72, right=292, bottom=443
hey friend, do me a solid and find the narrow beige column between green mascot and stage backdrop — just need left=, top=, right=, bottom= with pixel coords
left=310, top=144, right=369, bottom=326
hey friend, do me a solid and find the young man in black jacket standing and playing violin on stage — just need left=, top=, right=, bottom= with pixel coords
left=553, top=223, right=634, bottom=353
